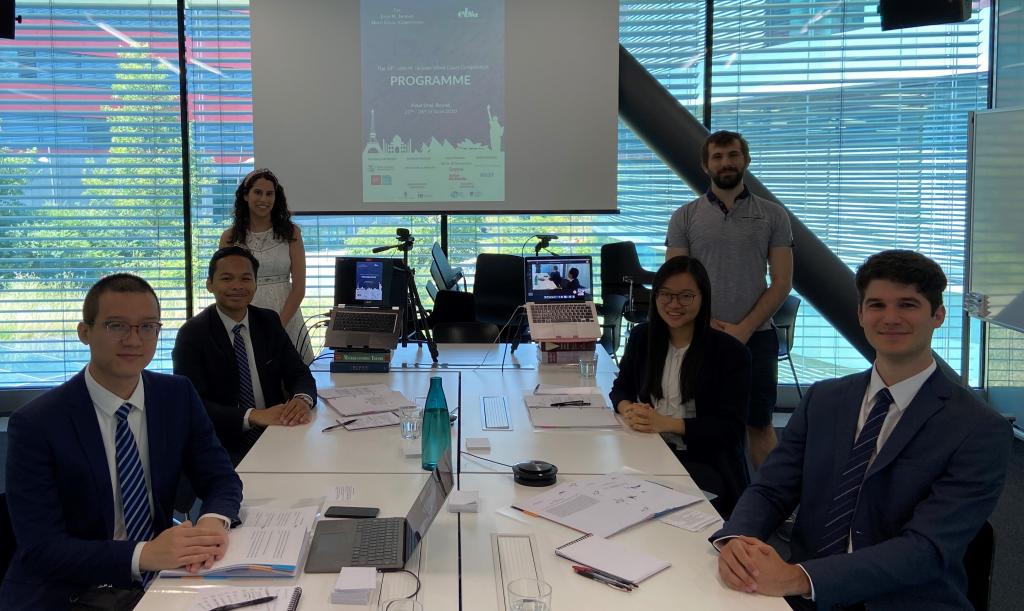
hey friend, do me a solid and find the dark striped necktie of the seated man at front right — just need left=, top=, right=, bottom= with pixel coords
left=814, top=388, right=893, bottom=558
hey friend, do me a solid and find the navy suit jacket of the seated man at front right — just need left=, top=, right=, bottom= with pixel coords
left=712, top=370, right=1013, bottom=611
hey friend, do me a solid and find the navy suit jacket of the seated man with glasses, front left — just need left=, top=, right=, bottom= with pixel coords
left=0, top=372, right=242, bottom=610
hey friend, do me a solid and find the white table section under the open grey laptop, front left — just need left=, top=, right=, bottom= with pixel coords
left=136, top=472, right=459, bottom=611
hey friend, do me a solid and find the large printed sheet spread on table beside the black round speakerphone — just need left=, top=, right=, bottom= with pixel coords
left=513, top=474, right=702, bottom=537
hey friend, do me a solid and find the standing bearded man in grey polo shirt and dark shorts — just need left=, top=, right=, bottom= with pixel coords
left=665, top=131, right=793, bottom=469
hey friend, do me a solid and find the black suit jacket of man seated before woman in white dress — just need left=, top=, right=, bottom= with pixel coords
left=172, top=305, right=316, bottom=465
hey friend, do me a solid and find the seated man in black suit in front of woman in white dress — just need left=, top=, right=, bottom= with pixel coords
left=172, top=246, right=316, bottom=465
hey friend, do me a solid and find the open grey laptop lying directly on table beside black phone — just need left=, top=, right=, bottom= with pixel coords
left=305, top=450, right=454, bottom=573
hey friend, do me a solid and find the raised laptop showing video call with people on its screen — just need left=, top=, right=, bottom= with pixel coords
left=525, top=256, right=601, bottom=341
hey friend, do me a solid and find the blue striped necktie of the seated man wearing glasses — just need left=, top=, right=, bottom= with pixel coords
left=114, top=403, right=154, bottom=583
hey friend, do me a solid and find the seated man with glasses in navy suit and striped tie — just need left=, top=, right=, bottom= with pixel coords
left=0, top=273, right=242, bottom=610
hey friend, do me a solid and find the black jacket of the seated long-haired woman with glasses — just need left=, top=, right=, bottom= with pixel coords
left=611, top=322, right=751, bottom=513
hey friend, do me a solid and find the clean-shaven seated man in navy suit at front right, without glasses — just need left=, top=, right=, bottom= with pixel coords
left=712, top=251, right=1013, bottom=611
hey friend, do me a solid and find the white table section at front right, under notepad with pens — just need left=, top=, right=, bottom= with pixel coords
left=460, top=474, right=790, bottom=611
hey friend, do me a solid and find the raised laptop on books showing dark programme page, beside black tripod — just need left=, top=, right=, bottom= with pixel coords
left=325, top=259, right=401, bottom=350
